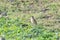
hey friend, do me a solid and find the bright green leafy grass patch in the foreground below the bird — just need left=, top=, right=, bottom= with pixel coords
left=0, top=18, right=56, bottom=40
